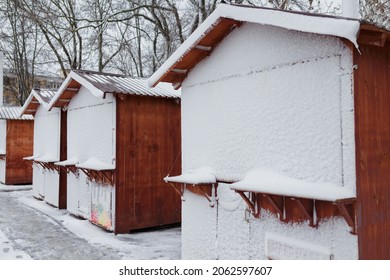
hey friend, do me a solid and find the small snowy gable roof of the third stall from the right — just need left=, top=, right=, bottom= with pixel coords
left=20, top=89, right=56, bottom=115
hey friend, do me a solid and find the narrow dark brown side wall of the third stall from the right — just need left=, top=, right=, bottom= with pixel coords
left=58, top=110, right=68, bottom=209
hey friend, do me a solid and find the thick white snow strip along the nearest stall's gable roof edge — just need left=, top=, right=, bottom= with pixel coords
left=148, top=5, right=360, bottom=86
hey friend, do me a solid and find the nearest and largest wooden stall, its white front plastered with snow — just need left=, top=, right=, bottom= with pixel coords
left=149, top=4, right=390, bottom=259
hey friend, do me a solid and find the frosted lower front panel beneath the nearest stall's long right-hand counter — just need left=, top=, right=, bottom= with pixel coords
left=250, top=210, right=358, bottom=260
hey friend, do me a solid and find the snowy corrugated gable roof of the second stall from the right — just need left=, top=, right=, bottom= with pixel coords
left=49, top=70, right=180, bottom=108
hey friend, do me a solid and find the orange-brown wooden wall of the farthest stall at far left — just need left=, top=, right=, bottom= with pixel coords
left=5, top=120, right=34, bottom=185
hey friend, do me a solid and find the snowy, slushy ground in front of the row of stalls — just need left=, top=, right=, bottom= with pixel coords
left=0, top=185, right=181, bottom=260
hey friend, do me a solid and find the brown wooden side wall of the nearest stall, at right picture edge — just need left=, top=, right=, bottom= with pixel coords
left=354, top=42, right=390, bottom=259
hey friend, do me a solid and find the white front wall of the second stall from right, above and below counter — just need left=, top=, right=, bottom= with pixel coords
left=67, top=86, right=116, bottom=226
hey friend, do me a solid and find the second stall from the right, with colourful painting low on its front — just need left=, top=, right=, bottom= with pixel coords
left=49, top=71, right=180, bottom=233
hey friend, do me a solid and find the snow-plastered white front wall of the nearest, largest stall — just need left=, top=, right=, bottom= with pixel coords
left=182, top=24, right=357, bottom=259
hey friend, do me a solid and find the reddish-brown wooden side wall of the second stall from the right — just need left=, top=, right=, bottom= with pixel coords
left=115, top=96, right=181, bottom=233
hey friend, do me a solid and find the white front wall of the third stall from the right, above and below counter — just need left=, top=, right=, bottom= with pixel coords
left=33, top=106, right=61, bottom=207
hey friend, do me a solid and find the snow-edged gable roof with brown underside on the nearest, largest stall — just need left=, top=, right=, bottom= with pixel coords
left=148, top=4, right=360, bottom=88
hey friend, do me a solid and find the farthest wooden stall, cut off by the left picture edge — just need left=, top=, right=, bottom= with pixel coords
left=0, top=107, right=34, bottom=185
